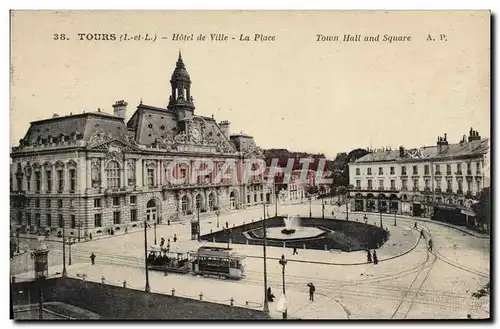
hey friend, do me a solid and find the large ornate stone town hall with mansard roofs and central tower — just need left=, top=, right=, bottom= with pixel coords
left=10, top=53, right=274, bottom=236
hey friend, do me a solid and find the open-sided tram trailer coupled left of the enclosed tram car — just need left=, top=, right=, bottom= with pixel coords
left=147, top=246, right=190, bottom=274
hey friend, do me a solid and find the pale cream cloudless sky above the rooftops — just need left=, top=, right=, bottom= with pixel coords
left=10, top=11, right=490, bottom=158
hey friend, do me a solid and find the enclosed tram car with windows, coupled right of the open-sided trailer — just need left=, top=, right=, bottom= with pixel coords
left=190, top=247, right=245, bottom=280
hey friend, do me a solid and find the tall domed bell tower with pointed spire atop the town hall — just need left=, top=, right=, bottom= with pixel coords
left=167, top=51, right=194, bottom=119
